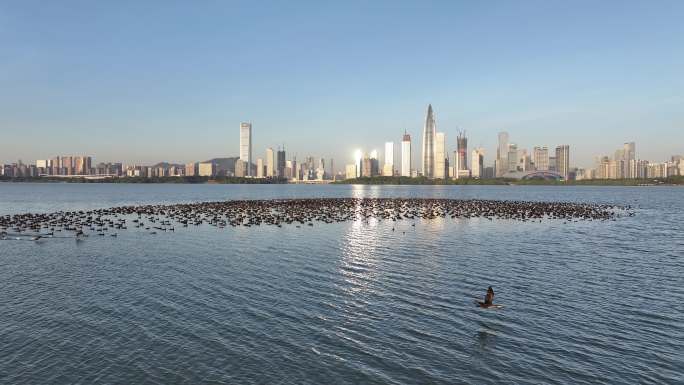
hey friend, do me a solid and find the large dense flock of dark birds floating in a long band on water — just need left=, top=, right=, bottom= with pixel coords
left=0, top=198, right=634, bottom=241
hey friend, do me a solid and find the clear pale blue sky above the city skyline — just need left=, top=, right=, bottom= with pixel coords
left=0, top=0, right=684, bottom=168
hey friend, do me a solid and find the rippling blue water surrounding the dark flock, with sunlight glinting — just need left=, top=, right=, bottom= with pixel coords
left=0, top=183, right=684, bottom=384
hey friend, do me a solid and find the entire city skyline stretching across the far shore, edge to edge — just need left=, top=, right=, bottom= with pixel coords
left=0, top=105, right=684, bottom=182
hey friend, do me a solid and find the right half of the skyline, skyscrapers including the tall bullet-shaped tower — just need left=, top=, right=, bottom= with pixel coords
left=345, top=105, right=684, bottom=180
